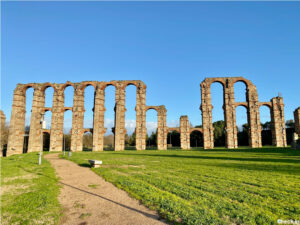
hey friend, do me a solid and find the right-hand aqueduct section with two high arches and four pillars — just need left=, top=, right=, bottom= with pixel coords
left=200, top=77, right=286, bottom=149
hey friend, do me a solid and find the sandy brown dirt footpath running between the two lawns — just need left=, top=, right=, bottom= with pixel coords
left=45, top=154, right=165, bottom=225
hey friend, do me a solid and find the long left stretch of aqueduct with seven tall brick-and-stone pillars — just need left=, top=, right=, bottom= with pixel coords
left=7, top=80, right=150, bottom=155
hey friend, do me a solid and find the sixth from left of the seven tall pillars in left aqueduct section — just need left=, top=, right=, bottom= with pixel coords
left=114, top=82, right=126, bottom=151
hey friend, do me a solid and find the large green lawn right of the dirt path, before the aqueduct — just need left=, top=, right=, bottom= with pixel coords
left=63, top=148, right=300, bottom=225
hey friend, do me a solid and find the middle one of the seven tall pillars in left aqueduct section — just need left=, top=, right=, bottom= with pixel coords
left=71, top=84, right=84, bottom=152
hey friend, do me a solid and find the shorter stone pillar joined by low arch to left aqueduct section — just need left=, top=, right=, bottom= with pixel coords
left=157, top=105, right=168, bottom=150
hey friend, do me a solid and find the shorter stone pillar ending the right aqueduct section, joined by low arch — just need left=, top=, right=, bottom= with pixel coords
left=271, top=97, right=287, bottom=147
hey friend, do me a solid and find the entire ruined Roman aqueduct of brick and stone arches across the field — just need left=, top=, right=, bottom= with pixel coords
left=2, top=77, right=300, bottom=156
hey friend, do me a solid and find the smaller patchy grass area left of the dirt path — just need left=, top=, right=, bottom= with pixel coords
left=1, top=153, right=62, bottom=225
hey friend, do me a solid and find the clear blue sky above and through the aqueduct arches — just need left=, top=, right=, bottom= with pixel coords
left=1, top=2, right=300, bottom=134
